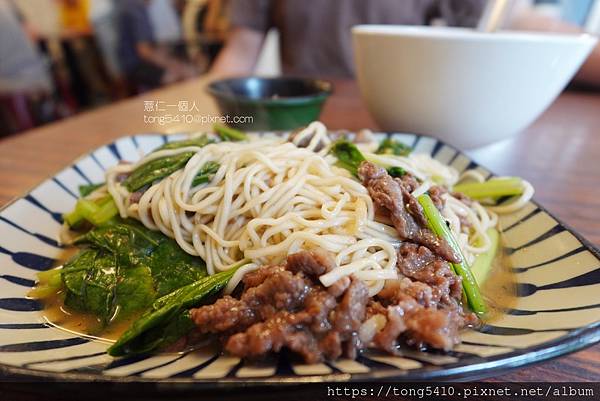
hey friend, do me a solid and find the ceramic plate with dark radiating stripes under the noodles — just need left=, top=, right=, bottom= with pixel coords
left=0, top=134, right=600, bottom=385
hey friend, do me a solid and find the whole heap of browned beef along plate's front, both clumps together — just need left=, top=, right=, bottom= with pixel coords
left=191, top=243, right=476, bottom=363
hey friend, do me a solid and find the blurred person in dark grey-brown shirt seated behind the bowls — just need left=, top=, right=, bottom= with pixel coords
left=211, top=0, right=600, bottom=85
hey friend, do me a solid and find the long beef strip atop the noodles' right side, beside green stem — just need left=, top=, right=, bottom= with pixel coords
left=358, top=161, right=460, bottom=263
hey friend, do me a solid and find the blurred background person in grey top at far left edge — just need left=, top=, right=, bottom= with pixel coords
left=0, top=0, right=54, bottom=136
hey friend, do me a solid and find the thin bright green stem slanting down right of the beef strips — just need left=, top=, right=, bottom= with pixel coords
left=417, top=194, right=486, bottom=314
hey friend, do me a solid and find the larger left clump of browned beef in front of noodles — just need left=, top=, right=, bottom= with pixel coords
left=191, top=249, right=369, bottom=363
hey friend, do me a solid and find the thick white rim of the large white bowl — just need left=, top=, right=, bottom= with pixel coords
left=352, top=24, right=598, bottom=46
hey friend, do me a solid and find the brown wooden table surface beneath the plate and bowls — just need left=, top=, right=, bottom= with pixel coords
left=0, top=79, right=600, bottom=381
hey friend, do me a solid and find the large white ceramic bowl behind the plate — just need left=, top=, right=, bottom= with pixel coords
left=352, top=25, right=597, bottom=149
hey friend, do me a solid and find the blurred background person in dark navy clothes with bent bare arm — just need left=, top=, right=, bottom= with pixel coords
left=117, top=0, right=197, bottom=92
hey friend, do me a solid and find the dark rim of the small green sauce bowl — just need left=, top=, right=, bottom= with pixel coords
left=205, top=75, right=333, bottom=105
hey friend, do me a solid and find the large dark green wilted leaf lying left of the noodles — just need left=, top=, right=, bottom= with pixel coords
left=61, top=220, right=206, bottom=325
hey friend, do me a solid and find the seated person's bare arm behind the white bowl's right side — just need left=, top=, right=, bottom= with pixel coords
left=510, top=10, right=600, bottom=87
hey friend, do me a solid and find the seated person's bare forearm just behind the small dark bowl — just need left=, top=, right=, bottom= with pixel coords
left=210, top=27, right=265, bottom=77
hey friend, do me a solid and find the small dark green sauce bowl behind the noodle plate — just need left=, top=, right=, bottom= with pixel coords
left=207, top=77, right=332, bottom=131
